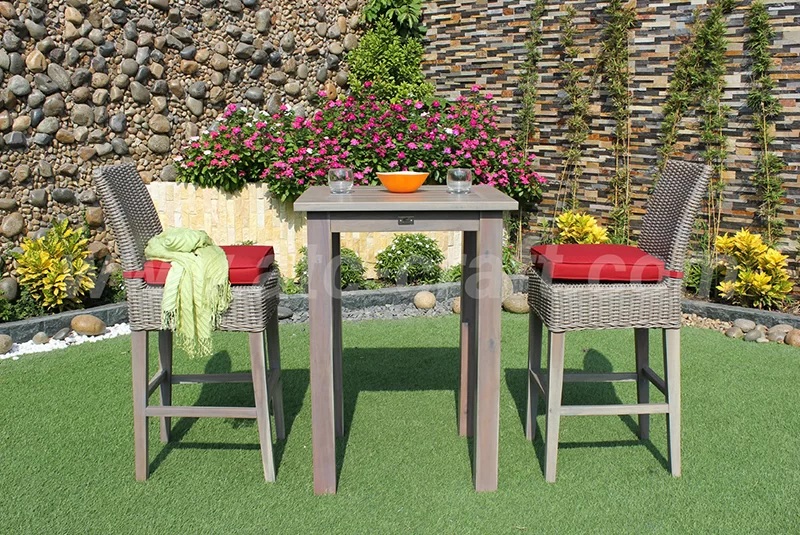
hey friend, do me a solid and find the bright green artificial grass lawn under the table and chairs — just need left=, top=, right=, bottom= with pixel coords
left=0, top=313, right=800, bottom=534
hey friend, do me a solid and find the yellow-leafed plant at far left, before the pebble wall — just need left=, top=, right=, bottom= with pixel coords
left=14, top=219, right=95, bottom=312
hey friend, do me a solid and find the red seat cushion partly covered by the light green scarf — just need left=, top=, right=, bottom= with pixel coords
left=125, top=245, right=275, bottom=286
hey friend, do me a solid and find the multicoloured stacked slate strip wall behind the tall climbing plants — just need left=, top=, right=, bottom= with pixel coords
left=418, top=0, right=800, bottom=274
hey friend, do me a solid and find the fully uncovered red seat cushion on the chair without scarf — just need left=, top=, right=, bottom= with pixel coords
left=531, top=244, right=682, bottom=282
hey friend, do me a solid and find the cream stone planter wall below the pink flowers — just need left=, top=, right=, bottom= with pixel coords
left=147, top=182, right=461, bottom=277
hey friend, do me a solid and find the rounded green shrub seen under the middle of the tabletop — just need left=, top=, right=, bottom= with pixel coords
left=375, top=234, right=444, bottom=284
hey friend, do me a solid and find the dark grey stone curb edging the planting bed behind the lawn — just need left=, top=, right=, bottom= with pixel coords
left=0, top=275, right=800, bottom=341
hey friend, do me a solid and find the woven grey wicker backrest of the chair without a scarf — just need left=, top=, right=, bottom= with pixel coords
left=638, top=160, right=711, bottom=271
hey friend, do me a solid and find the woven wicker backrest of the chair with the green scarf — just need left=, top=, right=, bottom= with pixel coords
left=94, top=163, right=163, bottom=271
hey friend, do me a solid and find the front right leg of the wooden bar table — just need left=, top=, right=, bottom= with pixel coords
left=474, top=212, right=503, bottom=492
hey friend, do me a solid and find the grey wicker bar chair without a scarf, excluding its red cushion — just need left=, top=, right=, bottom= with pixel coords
left=526, top=161, right=711, bottom=482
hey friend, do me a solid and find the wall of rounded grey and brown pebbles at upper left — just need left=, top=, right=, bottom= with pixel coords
left=0, top=0, right=360, bottom=268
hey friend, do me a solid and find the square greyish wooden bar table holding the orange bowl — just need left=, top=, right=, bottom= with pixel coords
left=294, top=186, right=517, bottom=494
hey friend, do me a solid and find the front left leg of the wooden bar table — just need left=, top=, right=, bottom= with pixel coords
left=308, top=213, right=336, bottom=494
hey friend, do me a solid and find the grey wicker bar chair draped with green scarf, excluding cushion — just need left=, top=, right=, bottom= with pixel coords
left=94, top=164, right=285, bottom=481
